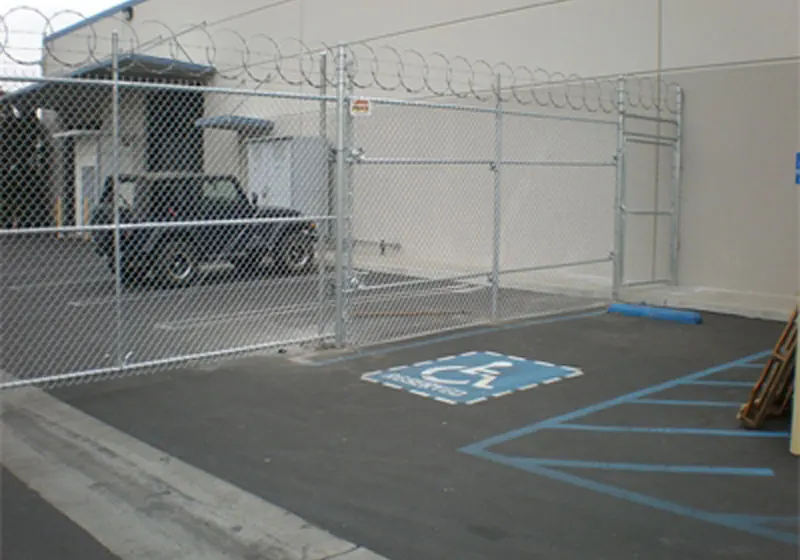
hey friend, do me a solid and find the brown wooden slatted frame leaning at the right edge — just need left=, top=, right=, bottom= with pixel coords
left=737, top=307, right=798, bottom=429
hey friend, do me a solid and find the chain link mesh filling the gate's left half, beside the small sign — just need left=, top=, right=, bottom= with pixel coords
left=351, top=102, right=494, bottom=343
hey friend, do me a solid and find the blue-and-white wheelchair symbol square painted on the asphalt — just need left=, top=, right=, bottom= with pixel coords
left=361, top=352, right=583, bottom=405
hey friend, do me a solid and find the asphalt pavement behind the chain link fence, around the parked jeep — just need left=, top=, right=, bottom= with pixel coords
left=0, top=234, right=597, bottom=379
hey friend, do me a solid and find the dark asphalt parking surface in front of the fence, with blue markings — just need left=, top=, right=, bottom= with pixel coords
left=6, top=311, right=798, bottom=560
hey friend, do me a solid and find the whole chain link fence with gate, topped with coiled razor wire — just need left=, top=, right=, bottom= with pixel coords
left=0, top=5, right=681, bottom=388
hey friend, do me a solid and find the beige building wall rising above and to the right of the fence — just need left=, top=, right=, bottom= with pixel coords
left=42, top=0, right=800, bottom=316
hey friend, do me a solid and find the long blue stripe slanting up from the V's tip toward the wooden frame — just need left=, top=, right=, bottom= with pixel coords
left=461, top=350, right=771, bottom=453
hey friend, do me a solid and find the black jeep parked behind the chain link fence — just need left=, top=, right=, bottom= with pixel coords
left=91, top=175, right=317, bottom=287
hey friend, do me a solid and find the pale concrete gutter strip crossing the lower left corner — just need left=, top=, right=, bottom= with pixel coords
left=0, top=382, right=385, bottom=560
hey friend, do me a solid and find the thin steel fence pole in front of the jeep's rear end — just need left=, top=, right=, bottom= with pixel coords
left=111, top=31, right=125, bottom=368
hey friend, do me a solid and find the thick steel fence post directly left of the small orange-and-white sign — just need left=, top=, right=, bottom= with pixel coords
left=335, top=44, right=347, bottom=347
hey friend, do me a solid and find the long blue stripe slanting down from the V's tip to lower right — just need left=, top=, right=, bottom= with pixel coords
left=473, top=450, right=798, bottom=545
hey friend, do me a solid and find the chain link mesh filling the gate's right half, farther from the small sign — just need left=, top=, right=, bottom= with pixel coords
left=500, top=101, right=617, bottom=317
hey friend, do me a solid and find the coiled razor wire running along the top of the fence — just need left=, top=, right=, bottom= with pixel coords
left=0, top=6, right=678, bottom=113
